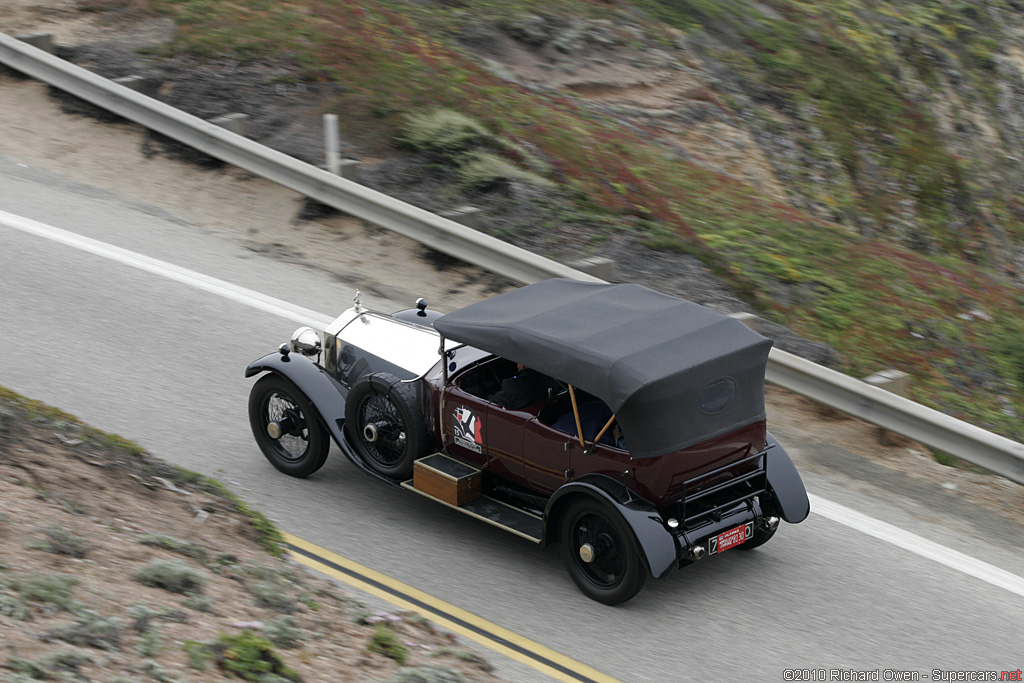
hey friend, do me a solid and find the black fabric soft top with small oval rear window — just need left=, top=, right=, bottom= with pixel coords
left=434, top=280, right=772, bottom=458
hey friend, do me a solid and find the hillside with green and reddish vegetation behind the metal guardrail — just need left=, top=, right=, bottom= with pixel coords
left=8, top=0, right=1024, bottom=446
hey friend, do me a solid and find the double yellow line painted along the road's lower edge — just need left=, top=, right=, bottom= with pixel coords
left=283, top=532, right=620, bottom=683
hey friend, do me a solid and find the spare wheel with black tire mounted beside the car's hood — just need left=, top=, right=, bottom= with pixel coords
left=345, top=373, right=430, bottom=480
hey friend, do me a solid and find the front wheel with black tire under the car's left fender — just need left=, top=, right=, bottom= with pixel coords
left=249, top=373, right=331, bottom=477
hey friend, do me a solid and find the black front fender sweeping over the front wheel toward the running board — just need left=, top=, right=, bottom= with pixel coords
left=246, top=352, right=396, bottom=484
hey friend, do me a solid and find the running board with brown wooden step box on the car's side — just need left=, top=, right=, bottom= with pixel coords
left=401, top=453, right=544, bottom=544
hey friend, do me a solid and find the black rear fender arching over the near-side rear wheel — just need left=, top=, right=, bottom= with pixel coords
left=542, top=474, right=679, bottom=579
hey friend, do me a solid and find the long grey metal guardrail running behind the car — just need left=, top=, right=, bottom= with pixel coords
left=0, top=33, right=1024, bottom=484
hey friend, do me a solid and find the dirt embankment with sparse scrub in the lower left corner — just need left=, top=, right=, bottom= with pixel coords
left=0, top=388, right=507, bottom=683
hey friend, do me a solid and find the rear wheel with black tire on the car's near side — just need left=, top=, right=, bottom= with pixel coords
left=559, top=498, right=647, bottom=605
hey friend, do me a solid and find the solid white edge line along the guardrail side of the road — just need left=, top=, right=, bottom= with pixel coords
left=6, top=206, right=1024, bottom=597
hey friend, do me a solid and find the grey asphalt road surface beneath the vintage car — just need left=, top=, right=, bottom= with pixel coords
left=0, top=157, right=1024, bottom=683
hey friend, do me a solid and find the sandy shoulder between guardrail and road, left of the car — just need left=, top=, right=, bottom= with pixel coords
left=0, top=74, right=509, bottom=310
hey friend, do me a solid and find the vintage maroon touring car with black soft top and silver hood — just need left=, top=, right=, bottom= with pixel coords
left=246, top=280, right=810, bottom=604
